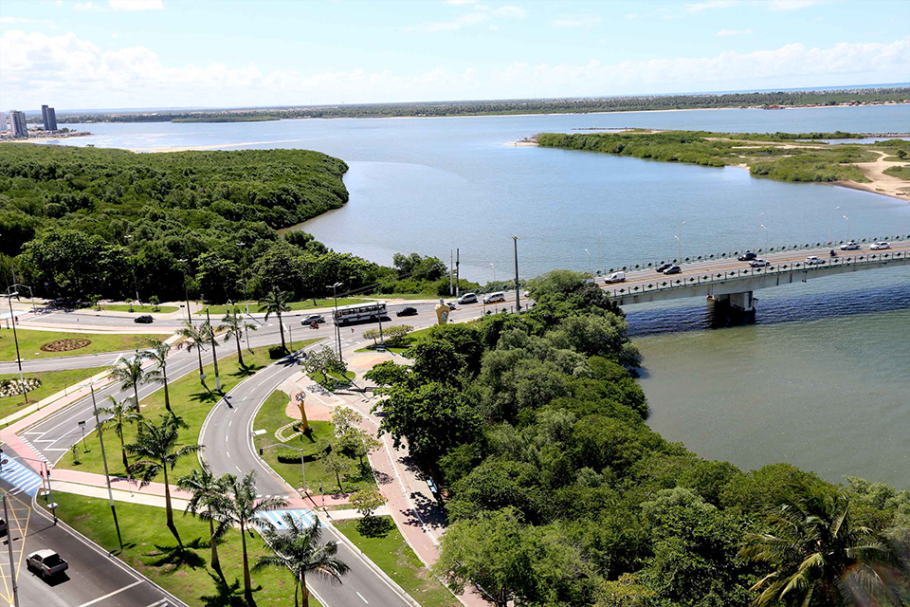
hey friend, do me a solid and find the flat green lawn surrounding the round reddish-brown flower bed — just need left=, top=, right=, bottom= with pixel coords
left=0, top=327, right=149, bottom=361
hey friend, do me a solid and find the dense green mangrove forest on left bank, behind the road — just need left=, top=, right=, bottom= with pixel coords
left=0, top=144, right=466, bottom=303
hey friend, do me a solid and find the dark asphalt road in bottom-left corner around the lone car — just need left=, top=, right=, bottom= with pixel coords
left=0, top=481, right=183, bottom=607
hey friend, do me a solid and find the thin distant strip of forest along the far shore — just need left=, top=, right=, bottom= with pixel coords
left=39, top=87, right=910, bottom=124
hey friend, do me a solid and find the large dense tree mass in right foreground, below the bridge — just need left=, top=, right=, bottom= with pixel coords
left=368, top=271, right=910, bottom=607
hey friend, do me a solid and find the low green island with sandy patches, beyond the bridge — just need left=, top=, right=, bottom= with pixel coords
left=535, top=129, right=910, bottom=200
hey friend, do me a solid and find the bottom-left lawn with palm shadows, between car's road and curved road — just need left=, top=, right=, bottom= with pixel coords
left=46, top=491, right=319, bottom=607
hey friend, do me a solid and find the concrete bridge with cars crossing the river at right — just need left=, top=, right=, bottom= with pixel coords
left=597, top=240, right=910, bottom=320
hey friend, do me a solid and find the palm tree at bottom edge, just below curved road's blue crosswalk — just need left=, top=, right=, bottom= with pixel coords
left=253, top=513, right=350, bottom=607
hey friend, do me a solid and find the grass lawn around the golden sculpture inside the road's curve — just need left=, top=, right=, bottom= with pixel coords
left=253, top=391, right=375, bottom=494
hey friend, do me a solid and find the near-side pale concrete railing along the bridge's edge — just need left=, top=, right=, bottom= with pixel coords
left=604, top=251, right=910, bottom=298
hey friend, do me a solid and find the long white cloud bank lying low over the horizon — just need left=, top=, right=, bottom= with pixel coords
left=0, top=30, right=910, bottom=109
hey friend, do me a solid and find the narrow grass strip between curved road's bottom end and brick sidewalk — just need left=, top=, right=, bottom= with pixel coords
left=335, top=516, right=461, bottom=607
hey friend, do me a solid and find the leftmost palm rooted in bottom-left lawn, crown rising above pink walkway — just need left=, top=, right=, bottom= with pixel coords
left=126, top=413, right=203, bottom=547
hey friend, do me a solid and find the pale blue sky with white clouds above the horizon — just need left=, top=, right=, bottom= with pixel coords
left=0, top=0, right=910, bottom=111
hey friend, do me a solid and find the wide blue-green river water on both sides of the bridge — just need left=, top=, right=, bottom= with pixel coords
left=55, top=105, right=910, bottom=488
